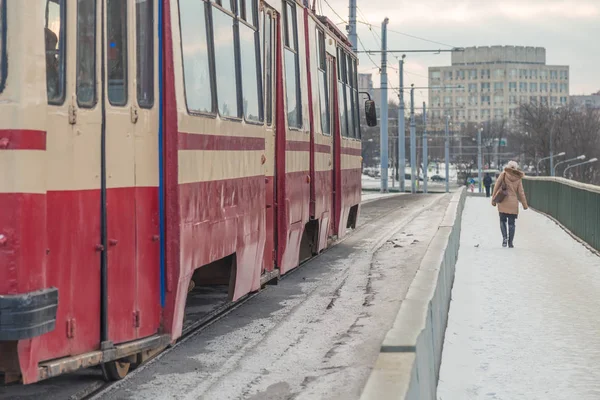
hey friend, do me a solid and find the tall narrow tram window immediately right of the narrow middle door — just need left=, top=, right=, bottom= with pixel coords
left=284, top=1, right=302, bottom=128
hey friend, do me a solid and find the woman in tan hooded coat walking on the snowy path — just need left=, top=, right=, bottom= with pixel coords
left=492, top=161, right=529, bottom=249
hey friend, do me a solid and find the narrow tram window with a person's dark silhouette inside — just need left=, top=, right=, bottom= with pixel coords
left=44, top=0, right=66, bottom=104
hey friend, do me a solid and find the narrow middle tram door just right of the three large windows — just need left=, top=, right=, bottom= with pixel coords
left=261, top=6, right=278, bottom=272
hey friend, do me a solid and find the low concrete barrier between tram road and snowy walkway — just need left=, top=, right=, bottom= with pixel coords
left=361, top=187, right=466, bottom=400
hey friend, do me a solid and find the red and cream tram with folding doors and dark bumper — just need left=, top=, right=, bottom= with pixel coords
left=0, top=0, right=376, bottom=384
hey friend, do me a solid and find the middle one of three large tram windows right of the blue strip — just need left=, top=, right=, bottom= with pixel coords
left=212, top=7, right=238, bottom=117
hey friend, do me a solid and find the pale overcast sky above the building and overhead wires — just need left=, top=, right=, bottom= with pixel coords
left=324, top=0, right=600, bottom=104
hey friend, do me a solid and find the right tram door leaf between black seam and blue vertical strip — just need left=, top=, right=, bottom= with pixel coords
left=103, top=0, right=160, bottom=343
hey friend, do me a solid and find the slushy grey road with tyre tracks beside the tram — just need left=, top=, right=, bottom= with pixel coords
left=92, top=195, right=450, bottom=400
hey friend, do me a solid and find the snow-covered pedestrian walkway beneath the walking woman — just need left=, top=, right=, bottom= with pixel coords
left=438, top=198, right=600, bottom=400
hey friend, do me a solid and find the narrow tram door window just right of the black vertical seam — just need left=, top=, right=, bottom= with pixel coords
left=106, top=0, right=127, bottom=106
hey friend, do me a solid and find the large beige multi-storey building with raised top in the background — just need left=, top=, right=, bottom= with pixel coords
left=429, top=46, right=569, bottom=123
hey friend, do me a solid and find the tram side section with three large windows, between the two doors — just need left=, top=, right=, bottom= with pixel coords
left=165, top=1, right=266, bottom=338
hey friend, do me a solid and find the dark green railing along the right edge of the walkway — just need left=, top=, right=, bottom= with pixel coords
left=523, top=177, right=600, bottom=251
